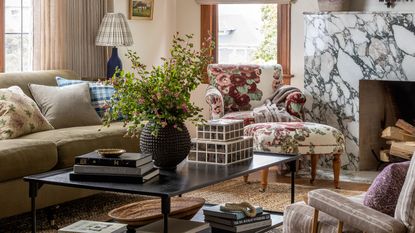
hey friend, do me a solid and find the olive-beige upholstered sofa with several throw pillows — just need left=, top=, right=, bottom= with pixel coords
left=0, top=70, right=139, bottom=218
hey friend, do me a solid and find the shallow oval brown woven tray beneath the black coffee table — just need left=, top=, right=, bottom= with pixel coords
left=108, top=197, right=205, bottom=226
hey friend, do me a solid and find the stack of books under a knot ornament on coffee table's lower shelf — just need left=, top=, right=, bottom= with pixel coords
left=203, top=205, right=272, bottom=232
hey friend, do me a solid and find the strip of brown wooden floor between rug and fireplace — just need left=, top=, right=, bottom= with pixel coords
left=249, top=169, right=370, bottom=191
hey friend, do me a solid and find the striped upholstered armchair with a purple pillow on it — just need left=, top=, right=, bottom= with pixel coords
left=284, top=156, right=415, bottom=233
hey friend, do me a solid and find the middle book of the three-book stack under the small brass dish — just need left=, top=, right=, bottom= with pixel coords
left=73, top=162, right=154, bottom=176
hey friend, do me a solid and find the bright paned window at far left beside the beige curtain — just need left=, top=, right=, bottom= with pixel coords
left=3, top=0, right=33, bottom=72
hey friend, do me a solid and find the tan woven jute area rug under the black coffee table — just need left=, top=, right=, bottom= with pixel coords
left=0, top=178, right=361, bottom=233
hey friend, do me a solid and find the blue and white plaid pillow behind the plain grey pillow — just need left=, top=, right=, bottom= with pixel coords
left=56, top=77, right=115, bottom=117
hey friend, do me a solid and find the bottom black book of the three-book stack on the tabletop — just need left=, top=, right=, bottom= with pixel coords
left=69, top=168, right=160, bottom=184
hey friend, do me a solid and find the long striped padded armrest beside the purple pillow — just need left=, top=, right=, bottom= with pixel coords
left=308, top=189, right=406, bottom=233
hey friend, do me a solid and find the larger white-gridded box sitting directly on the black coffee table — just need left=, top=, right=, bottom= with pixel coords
left=187, top=137, right=253, bottom=165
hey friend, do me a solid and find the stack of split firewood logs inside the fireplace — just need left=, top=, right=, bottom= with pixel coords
left=380, top=119, right=415, bottom=162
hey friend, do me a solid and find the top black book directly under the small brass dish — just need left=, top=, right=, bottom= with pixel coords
left=75, top=151, right=153, bottom=167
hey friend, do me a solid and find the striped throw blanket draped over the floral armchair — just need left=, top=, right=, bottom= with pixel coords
left=253, top=85, right=301, bottom=123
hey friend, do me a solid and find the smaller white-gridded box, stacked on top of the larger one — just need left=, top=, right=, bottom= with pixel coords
left=197, top=119, right=244, bottom=141
